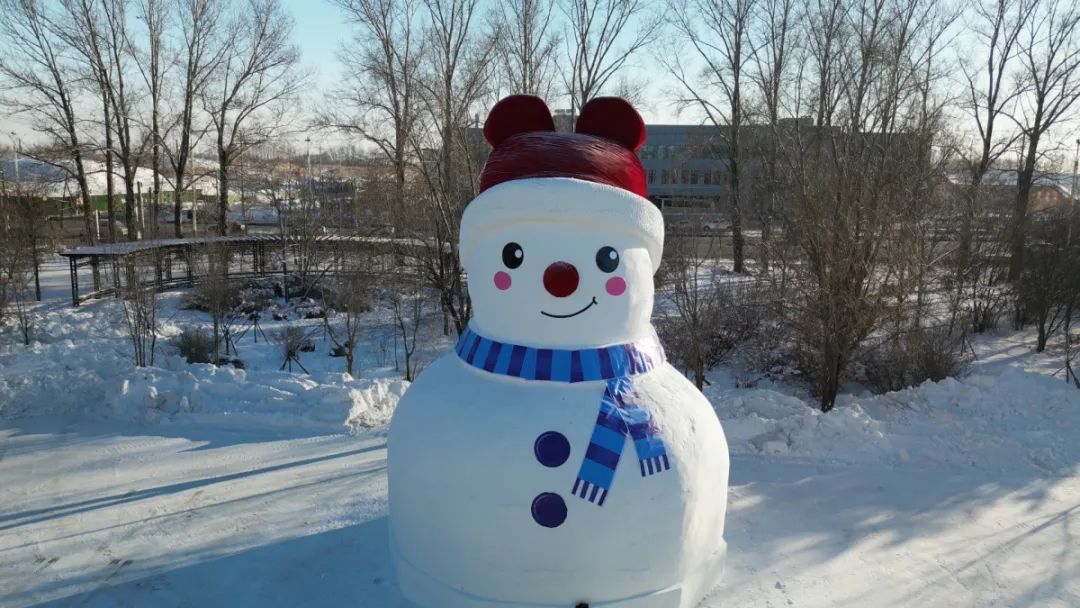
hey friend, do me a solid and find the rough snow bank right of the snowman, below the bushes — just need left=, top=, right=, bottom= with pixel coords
left=706, top=367, right=1080, bottom=474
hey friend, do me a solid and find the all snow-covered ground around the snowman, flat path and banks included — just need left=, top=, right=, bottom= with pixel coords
left=0, top=259, right=1080, bottom=608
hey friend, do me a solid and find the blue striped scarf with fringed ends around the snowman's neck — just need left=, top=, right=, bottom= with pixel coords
left=456, top=327, right=671, bottom=506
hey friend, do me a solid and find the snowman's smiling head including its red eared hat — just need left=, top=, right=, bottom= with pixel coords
left=460, top=95, right=663, bottom=349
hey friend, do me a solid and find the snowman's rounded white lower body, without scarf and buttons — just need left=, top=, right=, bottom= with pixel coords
left=390, top=353, right=728, bottom=608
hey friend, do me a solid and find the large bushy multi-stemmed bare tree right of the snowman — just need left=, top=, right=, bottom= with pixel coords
left=773, top=0, right=948, bottom=411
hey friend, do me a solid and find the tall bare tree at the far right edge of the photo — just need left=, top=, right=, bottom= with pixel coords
left=1009, top=0, right=1080, bottom=281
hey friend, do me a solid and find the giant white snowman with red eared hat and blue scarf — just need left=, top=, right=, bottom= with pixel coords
left=389, top=96, right=728, bottom=608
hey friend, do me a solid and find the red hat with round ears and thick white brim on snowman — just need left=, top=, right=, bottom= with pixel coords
left=460, top=95, right=664, bottom=271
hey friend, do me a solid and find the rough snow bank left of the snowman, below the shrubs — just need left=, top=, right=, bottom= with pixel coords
left=0, top=300, right=408, bottom=432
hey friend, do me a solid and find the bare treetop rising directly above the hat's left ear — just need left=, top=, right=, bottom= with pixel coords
left=496, top=0, right=562, bottom=98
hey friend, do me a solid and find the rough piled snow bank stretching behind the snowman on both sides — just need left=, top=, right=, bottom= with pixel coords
left=8, top=292, right=1080, bottom=481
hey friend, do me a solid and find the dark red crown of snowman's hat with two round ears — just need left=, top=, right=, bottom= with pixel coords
left=481, top=95, right=646, bottom=198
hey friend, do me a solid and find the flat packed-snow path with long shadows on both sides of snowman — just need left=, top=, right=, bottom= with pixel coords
left=0, top=421, right=1080, bottom=608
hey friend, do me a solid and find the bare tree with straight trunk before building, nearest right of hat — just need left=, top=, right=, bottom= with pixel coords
left=664, top=0, right=756, bottom=272
